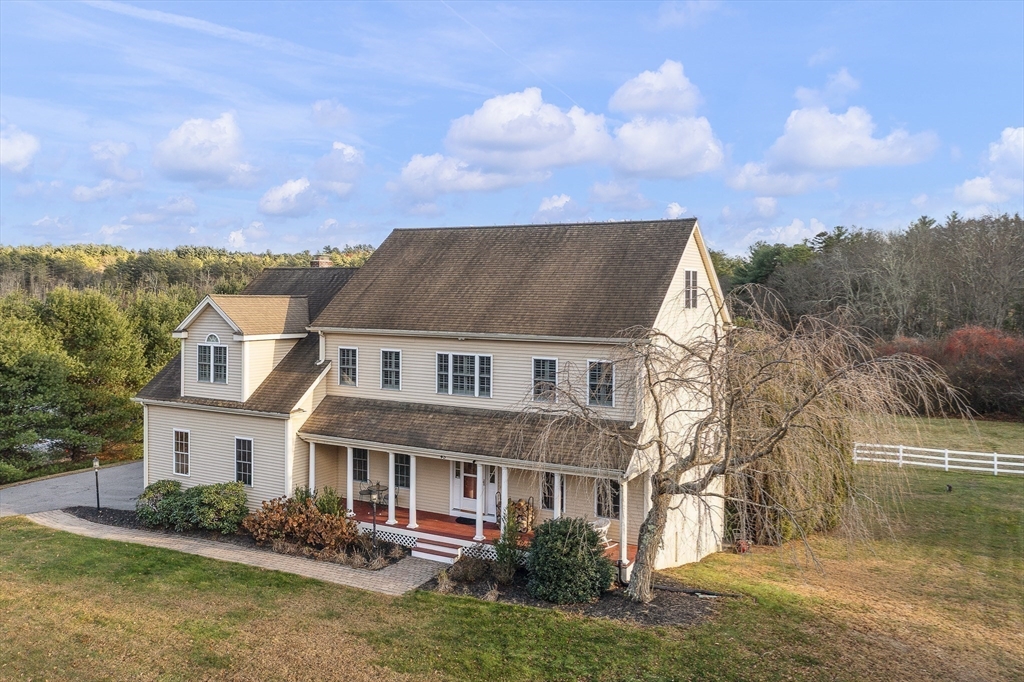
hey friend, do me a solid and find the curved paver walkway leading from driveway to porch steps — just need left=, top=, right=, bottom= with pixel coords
left=26, top=511, right=442, bottom=596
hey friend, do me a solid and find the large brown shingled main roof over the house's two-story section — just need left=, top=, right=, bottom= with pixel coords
left=311, top=219, right=696, bottom=339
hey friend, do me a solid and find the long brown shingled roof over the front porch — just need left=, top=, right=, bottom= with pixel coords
left=300, top=395, right=640, bottom=471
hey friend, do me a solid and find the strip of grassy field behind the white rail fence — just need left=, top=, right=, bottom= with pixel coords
left=857, top=417, right=1024, bottom=455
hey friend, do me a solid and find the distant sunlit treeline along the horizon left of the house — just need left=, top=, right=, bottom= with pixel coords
left=0, top=244, right=374, bottom=297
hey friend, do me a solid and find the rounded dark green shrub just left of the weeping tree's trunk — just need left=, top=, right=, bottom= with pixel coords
left=526, top=517, right=614, bottom=604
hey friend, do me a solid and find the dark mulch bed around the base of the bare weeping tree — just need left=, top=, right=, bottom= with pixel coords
left=422, top=571, right=729, bottom=627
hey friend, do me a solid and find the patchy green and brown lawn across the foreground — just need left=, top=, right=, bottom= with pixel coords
left=0, top=470, right=1024, bottom=680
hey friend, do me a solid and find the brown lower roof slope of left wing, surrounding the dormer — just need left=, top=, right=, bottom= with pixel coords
left=136, top=335, right=331, bottom=415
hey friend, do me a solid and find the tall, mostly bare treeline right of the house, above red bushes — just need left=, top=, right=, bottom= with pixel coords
left=713, top=213, right=1024, bottom=340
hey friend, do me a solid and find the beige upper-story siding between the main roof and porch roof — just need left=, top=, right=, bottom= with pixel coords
left=326, top=334, right=635, bottom=421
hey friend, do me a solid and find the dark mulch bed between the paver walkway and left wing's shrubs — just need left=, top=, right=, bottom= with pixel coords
left=62, top=507, right=409, bottom=570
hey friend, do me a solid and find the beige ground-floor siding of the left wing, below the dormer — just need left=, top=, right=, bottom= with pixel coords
left=146, top=406, right=285, bottom=509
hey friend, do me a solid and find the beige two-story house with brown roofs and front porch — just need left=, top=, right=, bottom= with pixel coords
left=137, top=219, right=727, bottom=572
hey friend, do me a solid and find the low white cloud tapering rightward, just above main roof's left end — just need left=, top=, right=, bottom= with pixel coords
left=388, top=154, right=528, bottom=199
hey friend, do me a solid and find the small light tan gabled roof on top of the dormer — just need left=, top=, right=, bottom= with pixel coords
left=175, top=294, right=309, bottom=336
